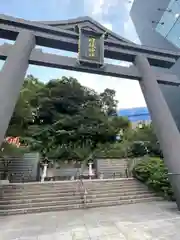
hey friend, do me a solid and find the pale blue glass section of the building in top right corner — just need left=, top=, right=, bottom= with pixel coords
left=156, top=0, right=180, bottom=47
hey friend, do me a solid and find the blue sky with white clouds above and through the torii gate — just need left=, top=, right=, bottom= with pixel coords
left=0, top=0, right=146, bottom=108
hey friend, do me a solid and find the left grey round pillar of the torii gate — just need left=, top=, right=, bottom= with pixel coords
left=0, top=30, right=35, bottom=145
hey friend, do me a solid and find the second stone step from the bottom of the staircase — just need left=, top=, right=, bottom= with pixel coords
left=0, top=193, right=159, bottom=210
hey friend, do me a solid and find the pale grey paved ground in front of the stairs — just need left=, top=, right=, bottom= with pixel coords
left=0, top=202, right=180, bottom=240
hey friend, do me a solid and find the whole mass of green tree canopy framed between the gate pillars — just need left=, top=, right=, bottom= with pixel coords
left=7, top=75, right=130, bottom=159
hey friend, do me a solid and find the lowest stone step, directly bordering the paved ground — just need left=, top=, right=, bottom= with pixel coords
left=0, top=196, right=162, bottom=216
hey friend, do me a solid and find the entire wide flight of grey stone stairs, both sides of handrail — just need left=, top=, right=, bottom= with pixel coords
left=0, top=178, right=161, bottom=215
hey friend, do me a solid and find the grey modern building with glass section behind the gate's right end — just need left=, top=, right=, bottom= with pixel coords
left=130, top=0, right=180, bottom=130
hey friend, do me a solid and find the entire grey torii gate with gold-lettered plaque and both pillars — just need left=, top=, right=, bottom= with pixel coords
left=0, top=15, right=180, bottom=207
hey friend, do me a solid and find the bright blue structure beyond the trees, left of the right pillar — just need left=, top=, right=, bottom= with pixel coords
left=118, top=107, right=151, bottom=122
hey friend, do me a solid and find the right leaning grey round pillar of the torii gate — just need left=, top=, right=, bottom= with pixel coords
left=135, top=55, right=180, bottom=210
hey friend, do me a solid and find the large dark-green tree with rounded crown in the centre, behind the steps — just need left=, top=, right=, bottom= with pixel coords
left=20, top=77, right=125, bottom=158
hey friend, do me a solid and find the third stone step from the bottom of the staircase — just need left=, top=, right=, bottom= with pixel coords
left=0, top=190, right=150, bottom=205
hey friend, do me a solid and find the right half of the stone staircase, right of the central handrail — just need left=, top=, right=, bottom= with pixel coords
left=85, top=178, right=162, bottom=207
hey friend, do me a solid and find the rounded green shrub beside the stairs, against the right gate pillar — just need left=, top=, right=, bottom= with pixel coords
left=133, top=158, right=174, bottom=200
